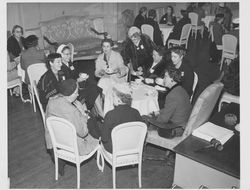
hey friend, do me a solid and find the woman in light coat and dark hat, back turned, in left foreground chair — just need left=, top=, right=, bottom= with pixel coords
left=45, top=79, right=98, bottom=175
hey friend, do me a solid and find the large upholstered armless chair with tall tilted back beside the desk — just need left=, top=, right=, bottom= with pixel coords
left=146, top=82, right=223, bottom=150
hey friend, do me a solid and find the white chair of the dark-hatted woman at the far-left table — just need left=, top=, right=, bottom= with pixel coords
left=27, top=63, right=48, bottom=112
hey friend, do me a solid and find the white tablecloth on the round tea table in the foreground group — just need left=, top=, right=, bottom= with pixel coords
left=104, top=83, right=159, bottom=115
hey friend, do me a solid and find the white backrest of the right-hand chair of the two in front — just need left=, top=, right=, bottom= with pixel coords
left=111, top=122, right=147, bottom=158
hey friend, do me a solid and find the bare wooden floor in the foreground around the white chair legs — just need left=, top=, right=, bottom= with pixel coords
left=8, top=96, right=174, bottom=189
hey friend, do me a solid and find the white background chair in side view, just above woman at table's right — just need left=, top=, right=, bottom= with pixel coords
left=168, top=24, right=192, bottom=49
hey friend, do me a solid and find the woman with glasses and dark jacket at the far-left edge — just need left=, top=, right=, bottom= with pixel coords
left=7, top=25, right=25, bottom=63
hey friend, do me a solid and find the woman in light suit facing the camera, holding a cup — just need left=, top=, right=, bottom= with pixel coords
left=95, top=39, right=128, bottom=95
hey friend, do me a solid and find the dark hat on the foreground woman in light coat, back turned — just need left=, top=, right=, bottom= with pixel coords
left=58, top=79, right=77, bottom=96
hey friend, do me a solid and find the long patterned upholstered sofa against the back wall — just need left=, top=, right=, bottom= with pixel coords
left=40, top=15, right=103, bottom=52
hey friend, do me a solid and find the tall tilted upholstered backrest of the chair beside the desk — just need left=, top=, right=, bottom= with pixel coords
left=183, top=82, right=224, bottom=138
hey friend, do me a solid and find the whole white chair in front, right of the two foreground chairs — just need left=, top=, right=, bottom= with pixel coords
left=101, top=122, right=147, bottom=188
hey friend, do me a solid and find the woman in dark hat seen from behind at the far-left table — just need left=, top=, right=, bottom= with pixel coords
left=20, top=35, right=46, bottom=84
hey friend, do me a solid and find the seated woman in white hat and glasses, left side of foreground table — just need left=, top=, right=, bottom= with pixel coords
left=57, top=44, right=104, bottom=117
